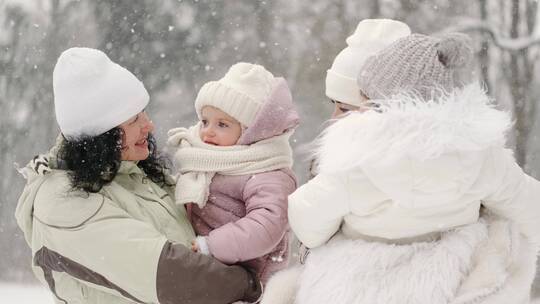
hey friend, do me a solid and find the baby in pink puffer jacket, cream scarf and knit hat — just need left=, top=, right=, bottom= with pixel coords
left=169, top=62, right=298, bottom=282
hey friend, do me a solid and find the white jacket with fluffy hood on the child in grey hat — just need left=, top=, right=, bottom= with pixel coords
left=289, top=84, right=540, bottom=248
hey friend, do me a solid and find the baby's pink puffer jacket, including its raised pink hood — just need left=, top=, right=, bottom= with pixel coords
left=189, top=78, right=299, bottom=282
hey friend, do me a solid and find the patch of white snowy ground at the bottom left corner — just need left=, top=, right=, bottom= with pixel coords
left=0, top=283, right=540, bottom=304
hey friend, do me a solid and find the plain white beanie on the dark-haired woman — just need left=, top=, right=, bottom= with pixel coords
left=53, top=48, right=149, bottom=139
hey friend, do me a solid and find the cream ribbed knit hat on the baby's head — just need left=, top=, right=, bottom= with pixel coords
left=195, top=62, right=275, bottom=127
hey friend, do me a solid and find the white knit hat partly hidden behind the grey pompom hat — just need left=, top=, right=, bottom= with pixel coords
left=326, top=19, right=411, bottom=106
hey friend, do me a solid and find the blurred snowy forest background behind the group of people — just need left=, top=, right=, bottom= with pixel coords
left=0, top=0, right=540, bottom=303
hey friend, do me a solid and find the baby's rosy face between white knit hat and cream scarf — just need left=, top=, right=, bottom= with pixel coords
left=199, top=106, right=242, bottom=146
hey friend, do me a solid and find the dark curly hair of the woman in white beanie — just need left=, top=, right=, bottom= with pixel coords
left=58, top=127, right=170, bottom=193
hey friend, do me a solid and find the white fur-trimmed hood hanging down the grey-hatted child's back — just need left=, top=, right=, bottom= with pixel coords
left=317, top=84, right=510, bottom=208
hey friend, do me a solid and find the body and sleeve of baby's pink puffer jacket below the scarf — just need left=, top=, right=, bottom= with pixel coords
left=191, top=169, right=296, bottom=282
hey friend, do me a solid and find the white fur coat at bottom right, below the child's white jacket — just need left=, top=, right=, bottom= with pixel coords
left=261, top=215, right=536, bottom=304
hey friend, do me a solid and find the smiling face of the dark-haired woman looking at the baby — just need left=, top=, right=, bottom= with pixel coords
left=120, top=111, right=154, bottom=161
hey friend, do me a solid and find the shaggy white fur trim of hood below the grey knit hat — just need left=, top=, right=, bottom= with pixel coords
left=316, top=83, right=511, bottom=172
